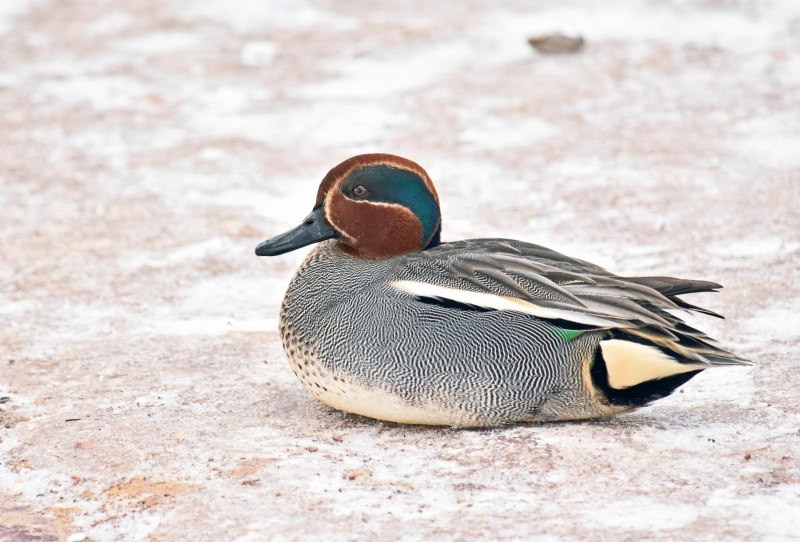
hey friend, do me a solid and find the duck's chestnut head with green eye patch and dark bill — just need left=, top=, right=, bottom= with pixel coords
left=256, top=154, right=441, bottom=259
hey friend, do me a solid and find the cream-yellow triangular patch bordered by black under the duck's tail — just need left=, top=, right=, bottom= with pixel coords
left=600, top=339, right=708, bottom=390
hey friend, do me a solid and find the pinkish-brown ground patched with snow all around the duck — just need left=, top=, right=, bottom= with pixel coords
left=0, top=0, right=800, bottom=542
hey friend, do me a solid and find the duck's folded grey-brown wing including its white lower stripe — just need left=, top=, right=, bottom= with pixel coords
left=390, top=239, right=749, bottom=365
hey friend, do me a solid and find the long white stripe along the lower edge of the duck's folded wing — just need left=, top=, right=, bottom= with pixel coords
left=390, top=280, right=629, bottom=327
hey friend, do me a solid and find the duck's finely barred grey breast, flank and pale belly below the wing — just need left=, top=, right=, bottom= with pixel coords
left=280, top=241, right=609, bottom=426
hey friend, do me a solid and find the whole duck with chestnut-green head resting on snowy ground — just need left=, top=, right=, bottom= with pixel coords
left=255, top=154, right=751, bottom=428
